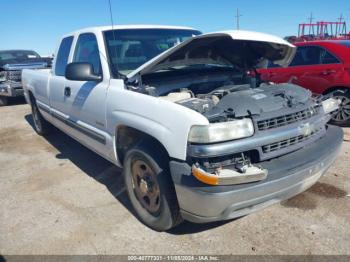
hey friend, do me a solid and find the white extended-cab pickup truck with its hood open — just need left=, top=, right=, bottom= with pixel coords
left=22, top=26, right=343, bottom=231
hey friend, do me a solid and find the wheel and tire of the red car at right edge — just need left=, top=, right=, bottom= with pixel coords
left=331, top=90, right=350, bottom=125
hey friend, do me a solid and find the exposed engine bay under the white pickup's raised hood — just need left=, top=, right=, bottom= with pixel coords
left=127, top=68, right=312, bottom=123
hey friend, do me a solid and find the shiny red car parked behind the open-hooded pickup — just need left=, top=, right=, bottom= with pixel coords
left=258, top=40, right=350, bottom=124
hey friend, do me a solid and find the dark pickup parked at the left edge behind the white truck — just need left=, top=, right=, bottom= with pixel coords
left=0, top=50, right=51, bottom=106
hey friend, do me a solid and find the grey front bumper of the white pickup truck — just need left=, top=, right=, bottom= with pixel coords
left=170, top=126, right=343, bottom=223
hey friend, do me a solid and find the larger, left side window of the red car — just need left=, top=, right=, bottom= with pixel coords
left=290, top=46, right=322, bottom=66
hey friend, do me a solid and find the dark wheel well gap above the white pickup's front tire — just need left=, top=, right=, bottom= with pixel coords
left=116, top=125, right=169, bottom=164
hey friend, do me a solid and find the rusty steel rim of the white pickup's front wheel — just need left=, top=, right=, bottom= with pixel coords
left=131, top=159, right=160, bottom=215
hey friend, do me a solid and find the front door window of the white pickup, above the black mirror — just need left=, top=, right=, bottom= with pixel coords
left=73, top=33, right=101, bottom=75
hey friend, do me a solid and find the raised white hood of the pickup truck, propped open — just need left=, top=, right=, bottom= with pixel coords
left=127, top=30, right=296, bottom=79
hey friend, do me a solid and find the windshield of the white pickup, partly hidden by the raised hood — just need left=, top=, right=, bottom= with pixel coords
left=104, top=29, right=201, bottom=76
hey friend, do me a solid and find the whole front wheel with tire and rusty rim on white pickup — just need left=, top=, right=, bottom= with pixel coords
left=123, top=145, right=183, bottom=231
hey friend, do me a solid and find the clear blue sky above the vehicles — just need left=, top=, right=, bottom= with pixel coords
left=0, top=0, right=350, bottom=55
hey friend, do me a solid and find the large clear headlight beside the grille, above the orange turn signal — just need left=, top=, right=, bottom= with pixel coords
left=188, top=118, right=254, bottom=143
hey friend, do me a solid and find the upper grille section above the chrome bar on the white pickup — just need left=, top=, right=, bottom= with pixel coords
left=257, top=107, right=318, bottom=131
